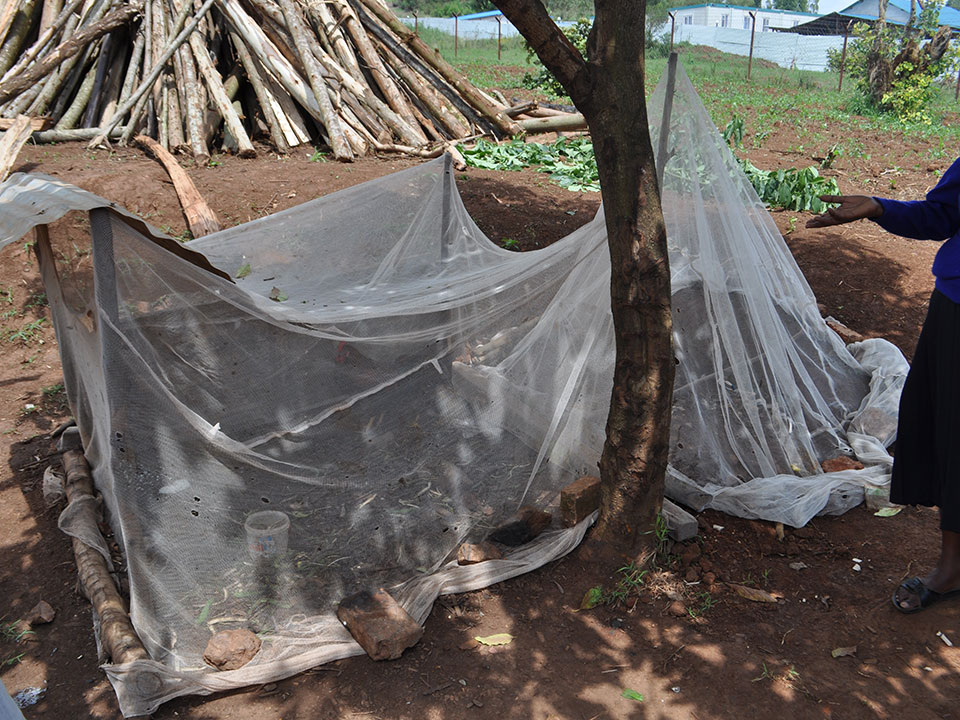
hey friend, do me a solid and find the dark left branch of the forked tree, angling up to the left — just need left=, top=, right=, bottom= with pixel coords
left=493, top=0, right=590, bottom=108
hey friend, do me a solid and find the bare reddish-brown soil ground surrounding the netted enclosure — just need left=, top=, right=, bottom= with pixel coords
left=0, top=126, right=960, bottom=720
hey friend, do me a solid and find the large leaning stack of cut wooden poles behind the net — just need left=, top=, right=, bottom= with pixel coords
left=0, top=0, right=584, bottom=162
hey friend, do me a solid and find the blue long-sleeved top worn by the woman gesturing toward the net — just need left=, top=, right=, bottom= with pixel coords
left=873, top=158, right=960, bottom=303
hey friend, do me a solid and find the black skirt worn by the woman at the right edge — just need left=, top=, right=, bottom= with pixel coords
left=890, top=290, right=960, bottom=532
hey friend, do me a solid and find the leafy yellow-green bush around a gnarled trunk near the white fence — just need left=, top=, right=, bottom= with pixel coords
left=829, top=0, right=958, bottom=124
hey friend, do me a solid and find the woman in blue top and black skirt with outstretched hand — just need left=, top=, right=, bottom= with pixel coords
left=807, top=159, right=960, bottom=613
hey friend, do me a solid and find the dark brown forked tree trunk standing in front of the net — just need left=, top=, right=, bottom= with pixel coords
left=494, top=0, right=675, bottom=559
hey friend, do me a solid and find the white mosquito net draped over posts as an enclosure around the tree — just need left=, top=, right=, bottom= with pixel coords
left=0, top=62, right=906, bottom=715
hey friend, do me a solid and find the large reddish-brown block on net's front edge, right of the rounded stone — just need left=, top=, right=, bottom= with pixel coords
left=337, top=588, right=423, bottom=660
